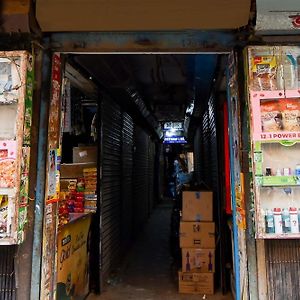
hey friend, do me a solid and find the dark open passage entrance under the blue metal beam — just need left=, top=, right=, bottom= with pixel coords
left=42, top=53, right=239, bottom=299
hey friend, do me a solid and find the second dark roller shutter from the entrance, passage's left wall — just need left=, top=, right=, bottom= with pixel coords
left=122, top=113, right=134, bottom=249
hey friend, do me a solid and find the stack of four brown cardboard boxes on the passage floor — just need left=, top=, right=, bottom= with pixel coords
left=179, top=191, right=215, bottom=294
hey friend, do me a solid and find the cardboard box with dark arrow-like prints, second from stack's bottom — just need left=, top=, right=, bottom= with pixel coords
left=182, top=248, right=215, bottom=273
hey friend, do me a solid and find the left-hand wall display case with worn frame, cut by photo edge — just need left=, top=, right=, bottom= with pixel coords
left=0, top=51, right=33, bottom=245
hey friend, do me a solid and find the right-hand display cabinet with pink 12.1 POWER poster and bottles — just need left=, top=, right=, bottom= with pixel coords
left=248, top=46, right=300, bottom=239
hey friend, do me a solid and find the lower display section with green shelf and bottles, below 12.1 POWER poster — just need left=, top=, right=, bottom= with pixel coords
left=253, top=141, right=300, bottom=238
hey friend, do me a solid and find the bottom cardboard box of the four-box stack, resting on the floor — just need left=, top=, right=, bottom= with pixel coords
left=178, top=272, right=214, bottom=295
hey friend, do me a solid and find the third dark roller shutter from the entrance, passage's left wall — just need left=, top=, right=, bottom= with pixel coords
left=133, top=127, right=150, bottom=234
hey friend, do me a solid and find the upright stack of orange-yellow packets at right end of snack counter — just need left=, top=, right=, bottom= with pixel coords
left=83, top=168, right=97, bottom=212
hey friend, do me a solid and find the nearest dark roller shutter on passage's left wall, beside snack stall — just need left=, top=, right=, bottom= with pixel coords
left=100, top=98, right=122, bottom=282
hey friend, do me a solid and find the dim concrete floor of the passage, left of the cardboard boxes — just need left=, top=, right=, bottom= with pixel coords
left=87, top=204, right=232, bottom=300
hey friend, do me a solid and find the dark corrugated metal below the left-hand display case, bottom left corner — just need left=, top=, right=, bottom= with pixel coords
left=0, top=246, right=16, bottom=300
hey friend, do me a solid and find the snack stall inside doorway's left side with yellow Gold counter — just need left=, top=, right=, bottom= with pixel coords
left=41, top=54, right=98, bottom=299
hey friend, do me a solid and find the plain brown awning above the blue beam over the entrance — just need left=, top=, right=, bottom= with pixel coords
left=36, top=0, right=251, bottom=32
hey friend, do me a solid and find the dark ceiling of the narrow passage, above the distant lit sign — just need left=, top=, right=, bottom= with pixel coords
left=70, top=54, right=218, bottom=127
